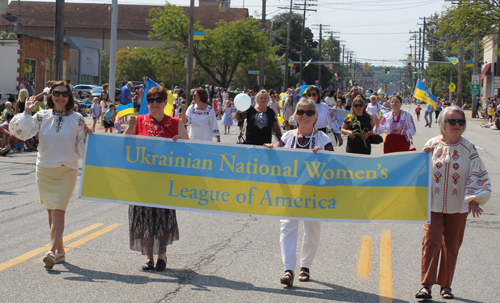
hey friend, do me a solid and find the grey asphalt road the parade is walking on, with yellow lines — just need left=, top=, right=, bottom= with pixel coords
left=0, top=105, right=500, bottom=303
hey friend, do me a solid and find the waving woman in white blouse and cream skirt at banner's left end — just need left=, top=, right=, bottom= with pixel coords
left=10, top=81, right=92, bottom=269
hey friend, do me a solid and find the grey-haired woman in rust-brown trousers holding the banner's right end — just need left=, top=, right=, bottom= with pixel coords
left=415, top=106, right=491, bottom=299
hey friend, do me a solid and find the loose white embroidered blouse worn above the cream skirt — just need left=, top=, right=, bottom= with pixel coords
left=9, top=110, right=85, bottom=169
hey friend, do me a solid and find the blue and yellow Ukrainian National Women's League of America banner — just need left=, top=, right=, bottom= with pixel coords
left=80, top=134, right=430, bottom=223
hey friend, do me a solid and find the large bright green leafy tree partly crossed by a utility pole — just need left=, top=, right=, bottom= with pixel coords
left=147, top=4, right=272, bottom=87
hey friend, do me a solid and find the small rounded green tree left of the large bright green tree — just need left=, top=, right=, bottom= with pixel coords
left=116, top=47, right=157, bottom=81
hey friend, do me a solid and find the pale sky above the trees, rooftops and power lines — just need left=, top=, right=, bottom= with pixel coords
left=15, top=0, right=451, bottom=66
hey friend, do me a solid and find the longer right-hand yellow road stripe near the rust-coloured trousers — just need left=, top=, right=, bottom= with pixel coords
left=378, top=229, right=393, bottom=303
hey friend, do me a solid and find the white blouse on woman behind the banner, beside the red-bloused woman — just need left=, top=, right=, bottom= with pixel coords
left=186, top=104, right=220, bottom=141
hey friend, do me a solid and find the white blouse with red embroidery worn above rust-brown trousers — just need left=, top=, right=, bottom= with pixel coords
left=424, top=137, right=491, bottom=214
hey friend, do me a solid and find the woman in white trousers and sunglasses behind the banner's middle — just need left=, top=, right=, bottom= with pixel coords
left=265, top=98, right=333, bottom=286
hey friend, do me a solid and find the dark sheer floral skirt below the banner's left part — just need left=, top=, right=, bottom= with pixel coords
left=128, top=205, right=179, bottom=255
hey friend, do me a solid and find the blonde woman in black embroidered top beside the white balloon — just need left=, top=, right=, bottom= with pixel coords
left=234, top=89, right=281, bottom=146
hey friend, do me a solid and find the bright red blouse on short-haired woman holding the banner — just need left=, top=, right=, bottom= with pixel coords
left=135, top=114, right=179, bottom=138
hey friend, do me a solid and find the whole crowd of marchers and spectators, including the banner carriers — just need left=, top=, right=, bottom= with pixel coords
left=0, top=81, right=492, bottom=299
